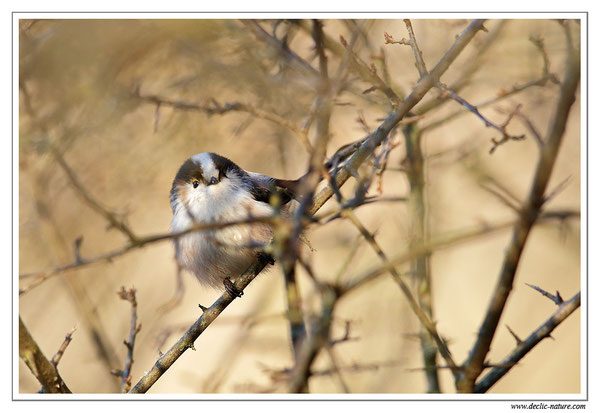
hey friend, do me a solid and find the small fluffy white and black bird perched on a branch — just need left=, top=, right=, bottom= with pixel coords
left=170, top=152, right=302, bottom=296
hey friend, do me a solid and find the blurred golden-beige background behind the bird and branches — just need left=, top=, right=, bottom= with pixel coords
left=19, top=19, right=581, bottom=393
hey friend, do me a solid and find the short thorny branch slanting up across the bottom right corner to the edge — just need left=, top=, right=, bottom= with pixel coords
left=473, top=292, right=581, bottom=393
